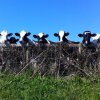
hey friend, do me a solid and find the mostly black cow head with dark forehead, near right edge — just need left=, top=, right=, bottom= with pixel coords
left=78, top=31, right=96, bottom=45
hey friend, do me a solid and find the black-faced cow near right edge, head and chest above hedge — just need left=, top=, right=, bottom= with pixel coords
left=78, top=30, right=96, bottom=52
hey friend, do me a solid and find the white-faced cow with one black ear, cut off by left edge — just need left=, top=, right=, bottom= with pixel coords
left=0, top=30, right=13, bottom=44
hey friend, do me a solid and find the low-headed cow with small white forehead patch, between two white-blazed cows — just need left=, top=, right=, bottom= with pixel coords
left=33, top=32, right=50, bottom=44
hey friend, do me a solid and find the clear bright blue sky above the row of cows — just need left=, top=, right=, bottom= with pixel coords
left=0, top=0, right=100, bottom=41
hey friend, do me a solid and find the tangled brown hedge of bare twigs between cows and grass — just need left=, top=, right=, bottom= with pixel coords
left=0, top=43, right=100, bottom=76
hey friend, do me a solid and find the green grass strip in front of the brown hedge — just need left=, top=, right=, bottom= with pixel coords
left=0, top=72, right=100, bottom=100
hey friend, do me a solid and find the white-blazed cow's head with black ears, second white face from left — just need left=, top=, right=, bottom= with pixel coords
left=15, top=30, right=31, bottom=44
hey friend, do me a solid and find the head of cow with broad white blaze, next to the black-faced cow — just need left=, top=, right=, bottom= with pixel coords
left=54, top=31, right=69, bottom=42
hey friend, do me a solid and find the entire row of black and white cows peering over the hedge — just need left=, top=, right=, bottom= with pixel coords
left=0, top=30, right=100, bottom=46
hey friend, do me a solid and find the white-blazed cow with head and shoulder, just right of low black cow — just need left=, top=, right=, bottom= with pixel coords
left=15, top=30, right=33, bottom=45
